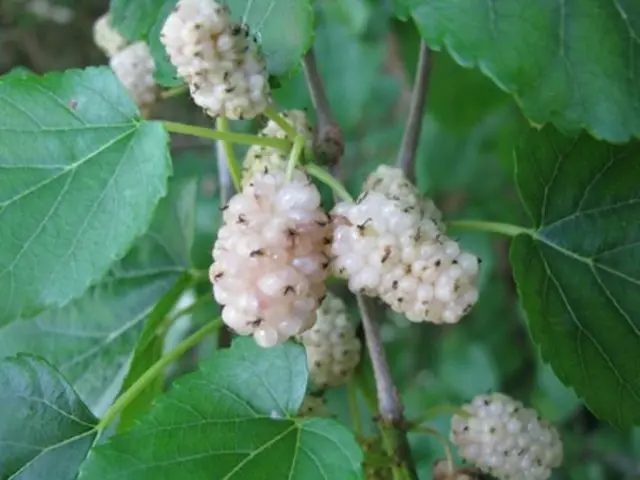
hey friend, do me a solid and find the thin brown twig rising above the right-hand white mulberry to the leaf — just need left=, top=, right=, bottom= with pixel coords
left=397, top=40, right=431, bottom=183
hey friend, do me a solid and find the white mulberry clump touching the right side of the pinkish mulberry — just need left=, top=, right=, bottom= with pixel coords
left=331, top=166, right=480, bottom=323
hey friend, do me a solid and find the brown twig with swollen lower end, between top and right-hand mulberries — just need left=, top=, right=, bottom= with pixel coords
left=303, top=49, right=344, bottom=166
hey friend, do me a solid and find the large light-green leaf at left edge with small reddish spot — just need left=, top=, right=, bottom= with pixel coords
left=0, top=68, right=171, bottom=325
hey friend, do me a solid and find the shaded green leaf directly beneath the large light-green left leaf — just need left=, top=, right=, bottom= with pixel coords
left=0, top=181, right=195, bottom=412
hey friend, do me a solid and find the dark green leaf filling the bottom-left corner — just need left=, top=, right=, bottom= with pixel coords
left=0, top=355, right=97, bottom=480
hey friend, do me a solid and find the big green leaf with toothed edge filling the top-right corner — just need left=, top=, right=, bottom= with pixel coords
left=411, top=0, right=640, bottom=142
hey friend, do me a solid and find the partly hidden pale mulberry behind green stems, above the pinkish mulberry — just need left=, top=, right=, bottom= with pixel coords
left=242, top=110, right=313, bottom=188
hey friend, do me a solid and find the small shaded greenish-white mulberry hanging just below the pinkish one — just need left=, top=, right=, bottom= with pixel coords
left=299, top=294, right=361, bottom=389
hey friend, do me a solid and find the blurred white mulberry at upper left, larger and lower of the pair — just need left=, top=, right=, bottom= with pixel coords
left=109, top=42, right=158, bottom=115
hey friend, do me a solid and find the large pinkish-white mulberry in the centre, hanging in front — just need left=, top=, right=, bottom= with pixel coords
left=210, top=170, right=331, bottom=347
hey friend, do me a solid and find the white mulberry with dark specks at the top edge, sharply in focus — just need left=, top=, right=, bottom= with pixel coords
left=160, top=0, right=270, bottom=119
